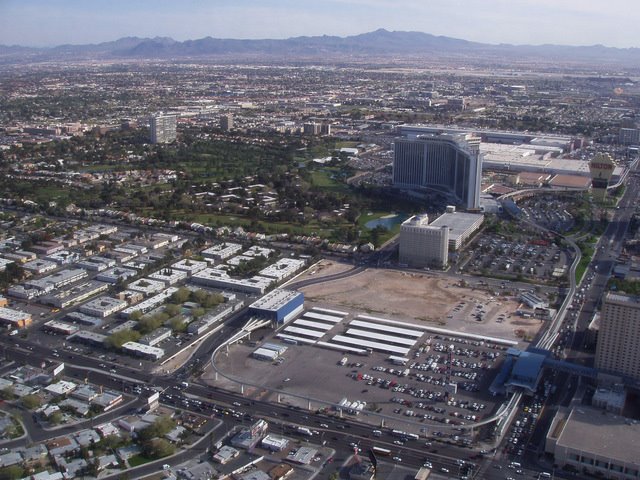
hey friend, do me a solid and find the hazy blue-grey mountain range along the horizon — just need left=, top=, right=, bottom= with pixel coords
left=0, top=29, right=640, bottom=68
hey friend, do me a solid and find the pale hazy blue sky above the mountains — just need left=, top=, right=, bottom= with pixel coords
left=0, top=0, right=640, bottom=47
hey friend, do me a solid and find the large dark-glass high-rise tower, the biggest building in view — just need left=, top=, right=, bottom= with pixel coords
left=393, top=134, right=482, bottom=209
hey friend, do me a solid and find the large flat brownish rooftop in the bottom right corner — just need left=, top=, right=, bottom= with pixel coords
left=557, top=407, right=640, bottom=467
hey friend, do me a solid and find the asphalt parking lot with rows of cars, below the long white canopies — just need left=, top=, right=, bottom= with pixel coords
left=210, top=312, right=509, bottom=444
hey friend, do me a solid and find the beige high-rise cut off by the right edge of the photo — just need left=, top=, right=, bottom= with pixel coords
left=595, top=293, right=640, bottom=381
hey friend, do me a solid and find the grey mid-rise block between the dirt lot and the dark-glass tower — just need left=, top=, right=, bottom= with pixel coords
left=399, top=215, right=449, bottom=268
